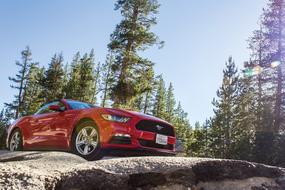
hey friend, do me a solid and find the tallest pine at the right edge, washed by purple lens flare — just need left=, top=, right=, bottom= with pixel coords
left=241, top=0, right=285, bottom=164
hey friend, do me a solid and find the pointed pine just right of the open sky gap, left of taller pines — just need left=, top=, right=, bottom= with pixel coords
left=212, top=57, right=238, bottom=158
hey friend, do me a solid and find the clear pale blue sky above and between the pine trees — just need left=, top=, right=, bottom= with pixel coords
left=0, top=0, right=267, bottom=123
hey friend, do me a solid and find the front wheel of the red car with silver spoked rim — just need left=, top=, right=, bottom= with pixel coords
left=71, top=121, right=104, bottom=160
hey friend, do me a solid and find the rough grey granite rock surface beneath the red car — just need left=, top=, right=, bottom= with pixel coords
left=0, top=152, right=285, bottom=190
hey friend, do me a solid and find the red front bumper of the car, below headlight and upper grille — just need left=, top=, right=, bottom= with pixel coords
left=101, top=119, right=176, bottom=156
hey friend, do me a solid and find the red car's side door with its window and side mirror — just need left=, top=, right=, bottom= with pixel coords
left=29, top=101, right=64, bottom=149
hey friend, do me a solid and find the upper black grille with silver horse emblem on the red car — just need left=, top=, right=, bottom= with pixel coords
left=136, top=120, right=174, bottom=137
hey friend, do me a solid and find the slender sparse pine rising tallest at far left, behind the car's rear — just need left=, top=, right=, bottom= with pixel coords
left=5, top=47, right=36, bottom=118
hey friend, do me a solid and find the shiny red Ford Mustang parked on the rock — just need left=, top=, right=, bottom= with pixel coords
left=7, top=99, right=176, bottom=160
